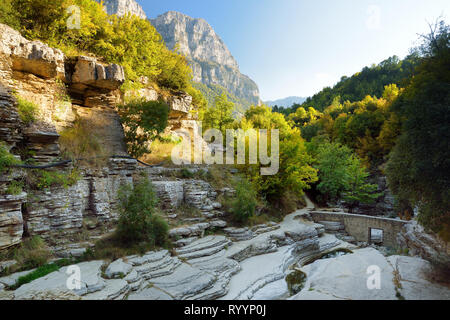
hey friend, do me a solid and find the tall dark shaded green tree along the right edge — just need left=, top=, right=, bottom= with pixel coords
left=386, top=22, right=450, bottom=234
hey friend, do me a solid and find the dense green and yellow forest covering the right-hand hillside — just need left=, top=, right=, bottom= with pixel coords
left=201, top=21, right=450, bottom=239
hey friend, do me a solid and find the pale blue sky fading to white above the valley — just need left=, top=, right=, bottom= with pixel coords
left=138, top=0, right=450, bottom=101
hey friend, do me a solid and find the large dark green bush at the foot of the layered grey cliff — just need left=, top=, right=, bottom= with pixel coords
left=115, top=179, right=169, bottom=245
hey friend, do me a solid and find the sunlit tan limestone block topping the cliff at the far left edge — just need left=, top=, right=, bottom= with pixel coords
left=0, top=24, right=64, bottom=79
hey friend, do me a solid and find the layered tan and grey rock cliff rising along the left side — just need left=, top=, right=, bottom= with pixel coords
left=0, top=24, right=200, bottom=250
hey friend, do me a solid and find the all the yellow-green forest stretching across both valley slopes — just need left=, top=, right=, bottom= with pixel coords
left=0, top=0, right=450, bottom=239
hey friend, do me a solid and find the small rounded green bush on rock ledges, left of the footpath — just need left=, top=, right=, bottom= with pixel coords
left=231, top=179, right=258, bottom=223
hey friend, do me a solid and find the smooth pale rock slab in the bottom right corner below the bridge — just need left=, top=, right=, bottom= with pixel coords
left=291, top=248, right=450, bottom=300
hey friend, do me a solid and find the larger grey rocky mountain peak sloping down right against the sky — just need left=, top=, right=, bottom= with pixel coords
left=150, top=11, right=260, bottom=107
